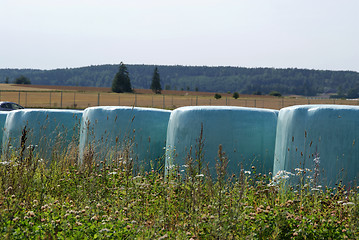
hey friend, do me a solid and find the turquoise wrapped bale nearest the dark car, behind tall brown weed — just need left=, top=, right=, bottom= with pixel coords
left=3, top=109, right=82, bottom=162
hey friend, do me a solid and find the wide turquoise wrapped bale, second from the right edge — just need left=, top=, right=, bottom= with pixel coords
left=166, top=106, right=278, bottom=177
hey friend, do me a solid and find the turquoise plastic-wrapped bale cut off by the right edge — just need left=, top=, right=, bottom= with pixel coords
left=273, top=105, right=359, bottom=186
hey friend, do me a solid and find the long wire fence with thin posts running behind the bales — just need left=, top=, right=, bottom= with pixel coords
left=0, top=91, right=359, bottom=109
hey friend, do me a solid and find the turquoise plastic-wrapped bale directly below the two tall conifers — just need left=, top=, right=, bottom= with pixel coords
left=79, top=107, right=171, bottom=172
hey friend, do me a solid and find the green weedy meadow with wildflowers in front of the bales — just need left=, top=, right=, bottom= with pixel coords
left=0, top=142, right=359, bottom=239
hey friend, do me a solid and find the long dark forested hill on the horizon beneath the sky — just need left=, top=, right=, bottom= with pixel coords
left=0, top=65, right=359, bottom=97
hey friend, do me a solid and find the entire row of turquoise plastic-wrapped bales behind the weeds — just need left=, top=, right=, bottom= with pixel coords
left=0, top=105, right=359, bottom=186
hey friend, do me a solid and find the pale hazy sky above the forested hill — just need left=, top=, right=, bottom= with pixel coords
left=0, top=0, right=359, bottom=71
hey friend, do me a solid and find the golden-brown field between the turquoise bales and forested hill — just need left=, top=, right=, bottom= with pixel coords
left=0, top=84, right=359, bottom=109
